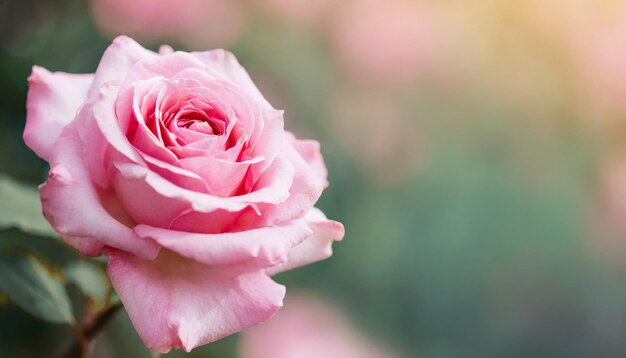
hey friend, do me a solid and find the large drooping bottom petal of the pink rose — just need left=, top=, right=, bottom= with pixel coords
left=106, top=250, right=285, bottom=353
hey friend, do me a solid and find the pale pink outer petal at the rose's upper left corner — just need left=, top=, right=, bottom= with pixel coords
left=24, top=66, right=93, bottom=161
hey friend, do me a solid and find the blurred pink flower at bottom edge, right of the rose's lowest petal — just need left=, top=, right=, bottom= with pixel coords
left=240, top=295, right=396, bottom=358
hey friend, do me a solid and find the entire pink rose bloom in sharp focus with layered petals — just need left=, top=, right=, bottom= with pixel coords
left=24, top=37, right=344, bottom=352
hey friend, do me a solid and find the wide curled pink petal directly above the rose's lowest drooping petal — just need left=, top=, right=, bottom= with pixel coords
left=135, top=220, right=313, bottom=267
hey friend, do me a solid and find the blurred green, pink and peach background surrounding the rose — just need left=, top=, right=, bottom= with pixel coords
left=0, top=0, right=626, bottom=358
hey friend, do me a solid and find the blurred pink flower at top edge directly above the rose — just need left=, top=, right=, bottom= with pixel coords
left=90, top=0, right=246, bottom=49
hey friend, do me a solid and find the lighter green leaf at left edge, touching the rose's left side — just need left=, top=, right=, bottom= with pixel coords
left=0, top=174, right=56, bottom=236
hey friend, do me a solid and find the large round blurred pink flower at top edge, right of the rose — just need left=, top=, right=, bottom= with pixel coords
left=332, top=0, right=446, bottom=84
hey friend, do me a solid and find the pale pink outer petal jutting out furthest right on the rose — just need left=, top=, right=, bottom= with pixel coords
left=267, top=208, right=345, bottom=275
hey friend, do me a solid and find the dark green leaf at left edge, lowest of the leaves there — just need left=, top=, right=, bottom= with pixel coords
left=0, top=251, right=74, bottom=323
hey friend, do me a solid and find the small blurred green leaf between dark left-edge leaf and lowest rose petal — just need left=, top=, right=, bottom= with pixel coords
left=64, top=260, right=110, bottom=303
